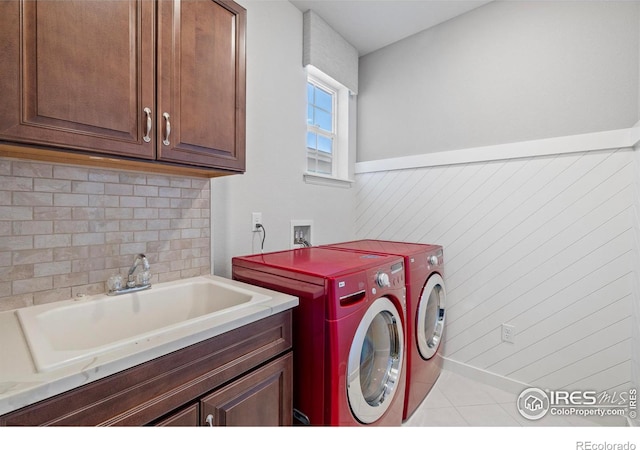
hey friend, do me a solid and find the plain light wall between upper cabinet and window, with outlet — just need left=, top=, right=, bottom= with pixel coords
left=211, top=0, right=355, bottom=277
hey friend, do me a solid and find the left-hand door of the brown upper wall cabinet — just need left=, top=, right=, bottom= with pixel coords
left=0, top=0, right=155, bottom=158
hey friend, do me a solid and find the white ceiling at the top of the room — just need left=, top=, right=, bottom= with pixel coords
left=289, top=0, right=490, bottom=56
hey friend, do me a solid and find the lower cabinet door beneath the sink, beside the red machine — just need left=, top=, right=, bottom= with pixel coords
left=200, top=353, right=293, bottom=426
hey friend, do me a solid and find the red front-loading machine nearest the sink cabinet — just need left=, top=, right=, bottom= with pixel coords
left=232, top=247, right=406, bottom=426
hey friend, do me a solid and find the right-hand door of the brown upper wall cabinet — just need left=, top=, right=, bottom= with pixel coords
left=157, top=0, right=246, bottom=171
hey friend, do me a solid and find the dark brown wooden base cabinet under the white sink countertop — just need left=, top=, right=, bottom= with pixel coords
left=0, top=311, right=293, bottom=426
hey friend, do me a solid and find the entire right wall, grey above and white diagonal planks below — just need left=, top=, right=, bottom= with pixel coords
left=356, top=1, right=640, bottom=400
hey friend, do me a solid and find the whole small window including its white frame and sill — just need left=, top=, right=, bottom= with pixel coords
left=304, top=66, right=355, bottom=187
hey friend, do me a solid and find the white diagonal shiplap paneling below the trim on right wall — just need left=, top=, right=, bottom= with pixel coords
left=356, top=148, right=637, bottom=390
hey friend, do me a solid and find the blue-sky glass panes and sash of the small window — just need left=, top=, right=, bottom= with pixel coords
left=307, top=78, right=337, bottom=176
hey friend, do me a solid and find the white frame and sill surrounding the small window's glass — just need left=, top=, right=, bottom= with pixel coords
left=304, top=65, right=353, bottom=188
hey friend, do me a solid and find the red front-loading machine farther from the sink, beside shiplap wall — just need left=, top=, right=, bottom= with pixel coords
left=323, top=239, right=446, bottom=420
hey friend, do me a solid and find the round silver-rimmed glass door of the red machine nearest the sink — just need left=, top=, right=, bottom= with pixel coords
left=347, top=297, right=404, bottom=423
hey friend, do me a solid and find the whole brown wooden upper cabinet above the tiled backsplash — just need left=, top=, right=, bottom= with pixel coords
left=0, top=0, right=246, bottom=176
